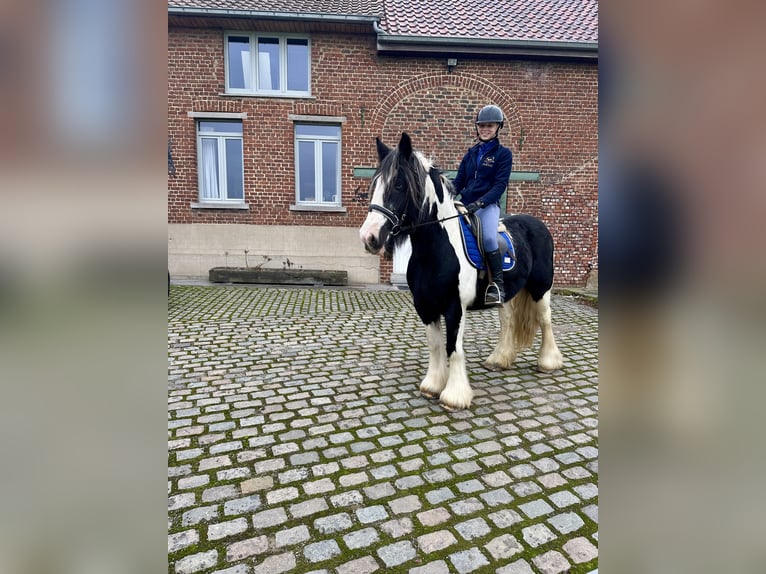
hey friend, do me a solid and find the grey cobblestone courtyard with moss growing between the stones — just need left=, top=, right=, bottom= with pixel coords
left=168, top=285, right=598, bottom=574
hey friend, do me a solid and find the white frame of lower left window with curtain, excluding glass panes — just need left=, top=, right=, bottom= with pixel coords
left=194, top=114, right=248, bottom=209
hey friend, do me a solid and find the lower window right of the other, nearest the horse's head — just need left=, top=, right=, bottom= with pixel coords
left=295, top=124, right=341, bottom=206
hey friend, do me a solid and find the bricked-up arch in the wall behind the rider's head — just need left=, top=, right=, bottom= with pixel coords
left=369, top=72, right=522, bottom=165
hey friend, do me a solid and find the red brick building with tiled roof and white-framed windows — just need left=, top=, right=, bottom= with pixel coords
left=168, top=0, right=598, bottom=286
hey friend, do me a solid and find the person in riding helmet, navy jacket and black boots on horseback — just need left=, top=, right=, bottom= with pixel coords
left=453, top=105, right=513, bottom=305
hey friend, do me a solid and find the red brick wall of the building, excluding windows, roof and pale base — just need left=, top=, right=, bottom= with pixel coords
left=168, top=28, right=598, bottom=285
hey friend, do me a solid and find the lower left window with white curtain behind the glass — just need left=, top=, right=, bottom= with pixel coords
left=197, top=120, right=245, bottom=203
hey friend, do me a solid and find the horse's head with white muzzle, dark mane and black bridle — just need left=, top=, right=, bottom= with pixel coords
left=359, top=133, right=431, bottom=257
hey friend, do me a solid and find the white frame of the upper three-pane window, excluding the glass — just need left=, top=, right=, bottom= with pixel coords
left=223, top=31, right=311, bottom=97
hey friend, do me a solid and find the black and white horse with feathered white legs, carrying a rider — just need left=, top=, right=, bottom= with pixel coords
left=359, top=133, right=563, bottom=410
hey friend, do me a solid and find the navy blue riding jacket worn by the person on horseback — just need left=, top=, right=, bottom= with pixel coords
left=452, top=139, right=513, bottom=205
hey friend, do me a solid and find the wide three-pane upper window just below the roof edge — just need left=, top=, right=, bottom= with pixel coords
left=225, top=32, right=311, bottom=96
